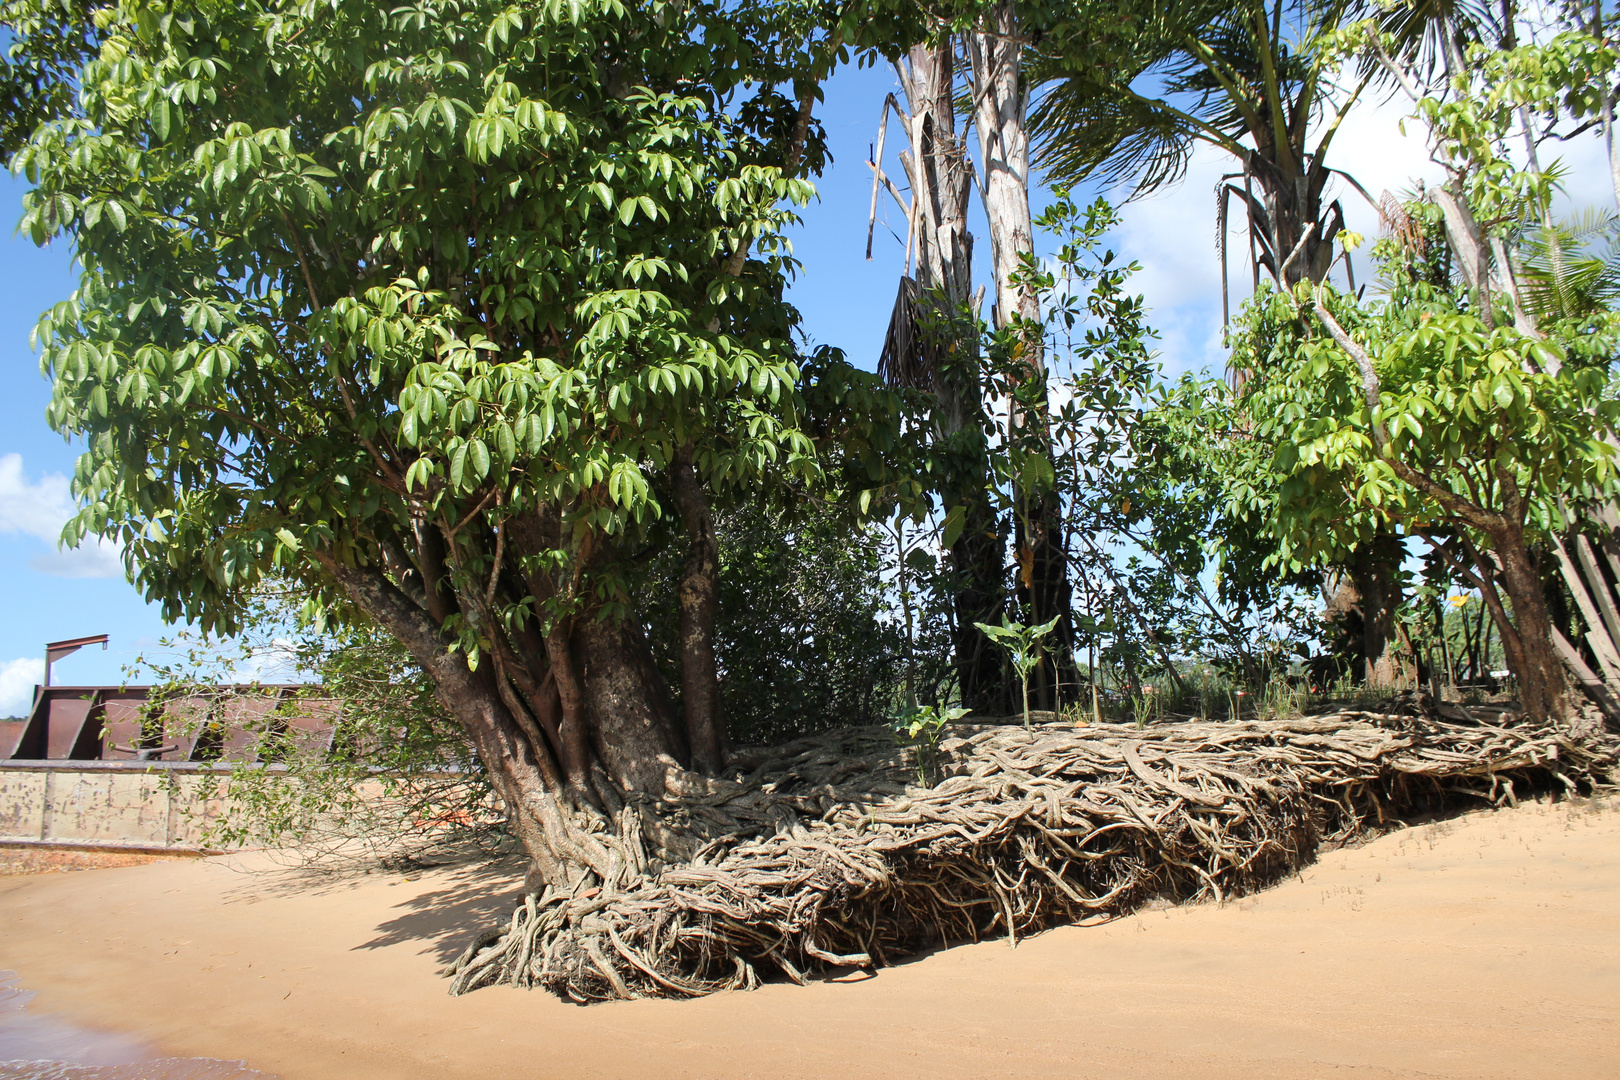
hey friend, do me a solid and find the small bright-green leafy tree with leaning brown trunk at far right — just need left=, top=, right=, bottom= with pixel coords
left=1259, top=275, right=1620, bottom=721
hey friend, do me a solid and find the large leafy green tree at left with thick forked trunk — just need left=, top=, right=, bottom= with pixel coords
left=16, top=0, right=859, bottom=886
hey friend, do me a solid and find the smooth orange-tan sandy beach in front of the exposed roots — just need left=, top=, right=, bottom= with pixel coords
left=0, top=801, right=1620, bottom=1080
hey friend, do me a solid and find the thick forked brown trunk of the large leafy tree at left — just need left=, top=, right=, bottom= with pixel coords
left=319, top=515, right=689, bottom=891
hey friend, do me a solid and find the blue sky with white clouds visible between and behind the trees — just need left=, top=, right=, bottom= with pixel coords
left=0, top=55, right=1614, bottom=716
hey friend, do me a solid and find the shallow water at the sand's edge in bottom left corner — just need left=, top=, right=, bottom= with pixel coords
left=0, top=972, right=275, bottom=1080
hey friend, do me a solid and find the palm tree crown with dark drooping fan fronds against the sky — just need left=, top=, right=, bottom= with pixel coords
left=1030, top=0, right=1372, bottom=314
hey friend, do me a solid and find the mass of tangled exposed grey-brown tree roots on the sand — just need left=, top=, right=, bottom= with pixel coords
left=447, top=712, right=1620, bottom=1002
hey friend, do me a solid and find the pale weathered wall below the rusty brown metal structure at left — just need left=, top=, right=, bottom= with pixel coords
left=0, top=761, right=236, bottom=852
